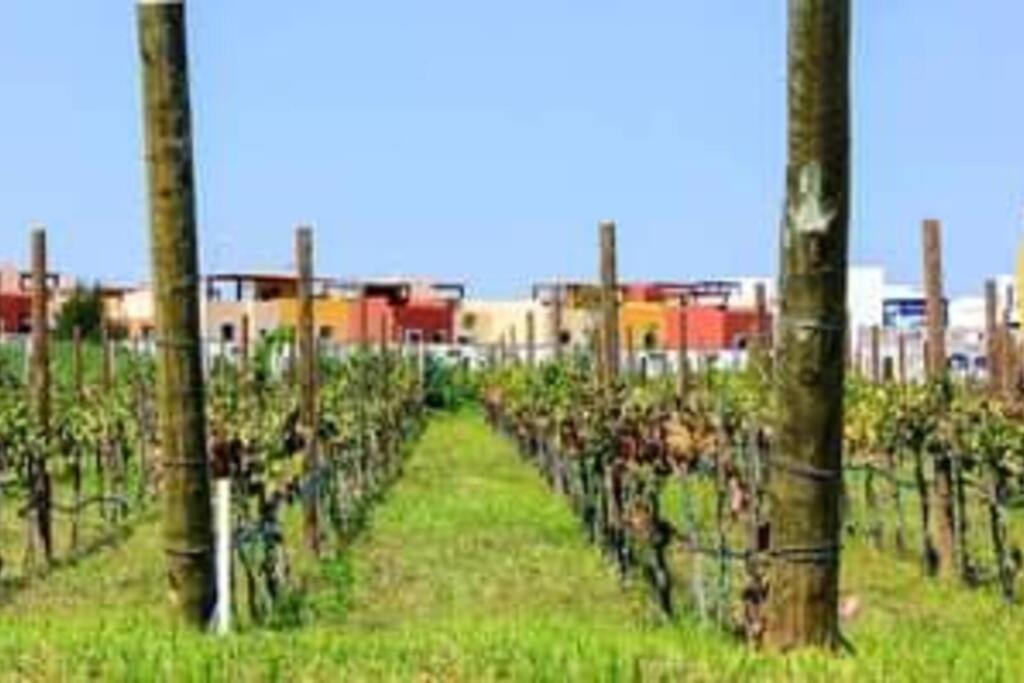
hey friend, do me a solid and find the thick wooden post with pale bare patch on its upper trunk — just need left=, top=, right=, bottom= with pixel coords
left=764, top=0, right=850, bottom=650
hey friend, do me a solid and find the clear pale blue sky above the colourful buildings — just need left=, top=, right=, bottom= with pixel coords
left=0, top=0, right=1024, bottom=295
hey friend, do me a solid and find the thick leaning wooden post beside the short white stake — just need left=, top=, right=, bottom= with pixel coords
left=138, top=0, right=216, bottom=627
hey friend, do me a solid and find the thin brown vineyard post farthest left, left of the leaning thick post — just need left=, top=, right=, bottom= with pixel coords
left=29, top=227, right=53, bottom=564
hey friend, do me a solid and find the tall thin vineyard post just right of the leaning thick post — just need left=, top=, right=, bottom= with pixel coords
left=295, top=226, right=321, bottom=555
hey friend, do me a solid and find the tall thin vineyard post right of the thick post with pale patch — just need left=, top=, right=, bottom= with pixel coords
left=923, top=220, right=956, bottom=575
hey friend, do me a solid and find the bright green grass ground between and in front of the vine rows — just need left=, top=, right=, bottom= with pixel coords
left=0, top=414, right=1024, bottom=682
